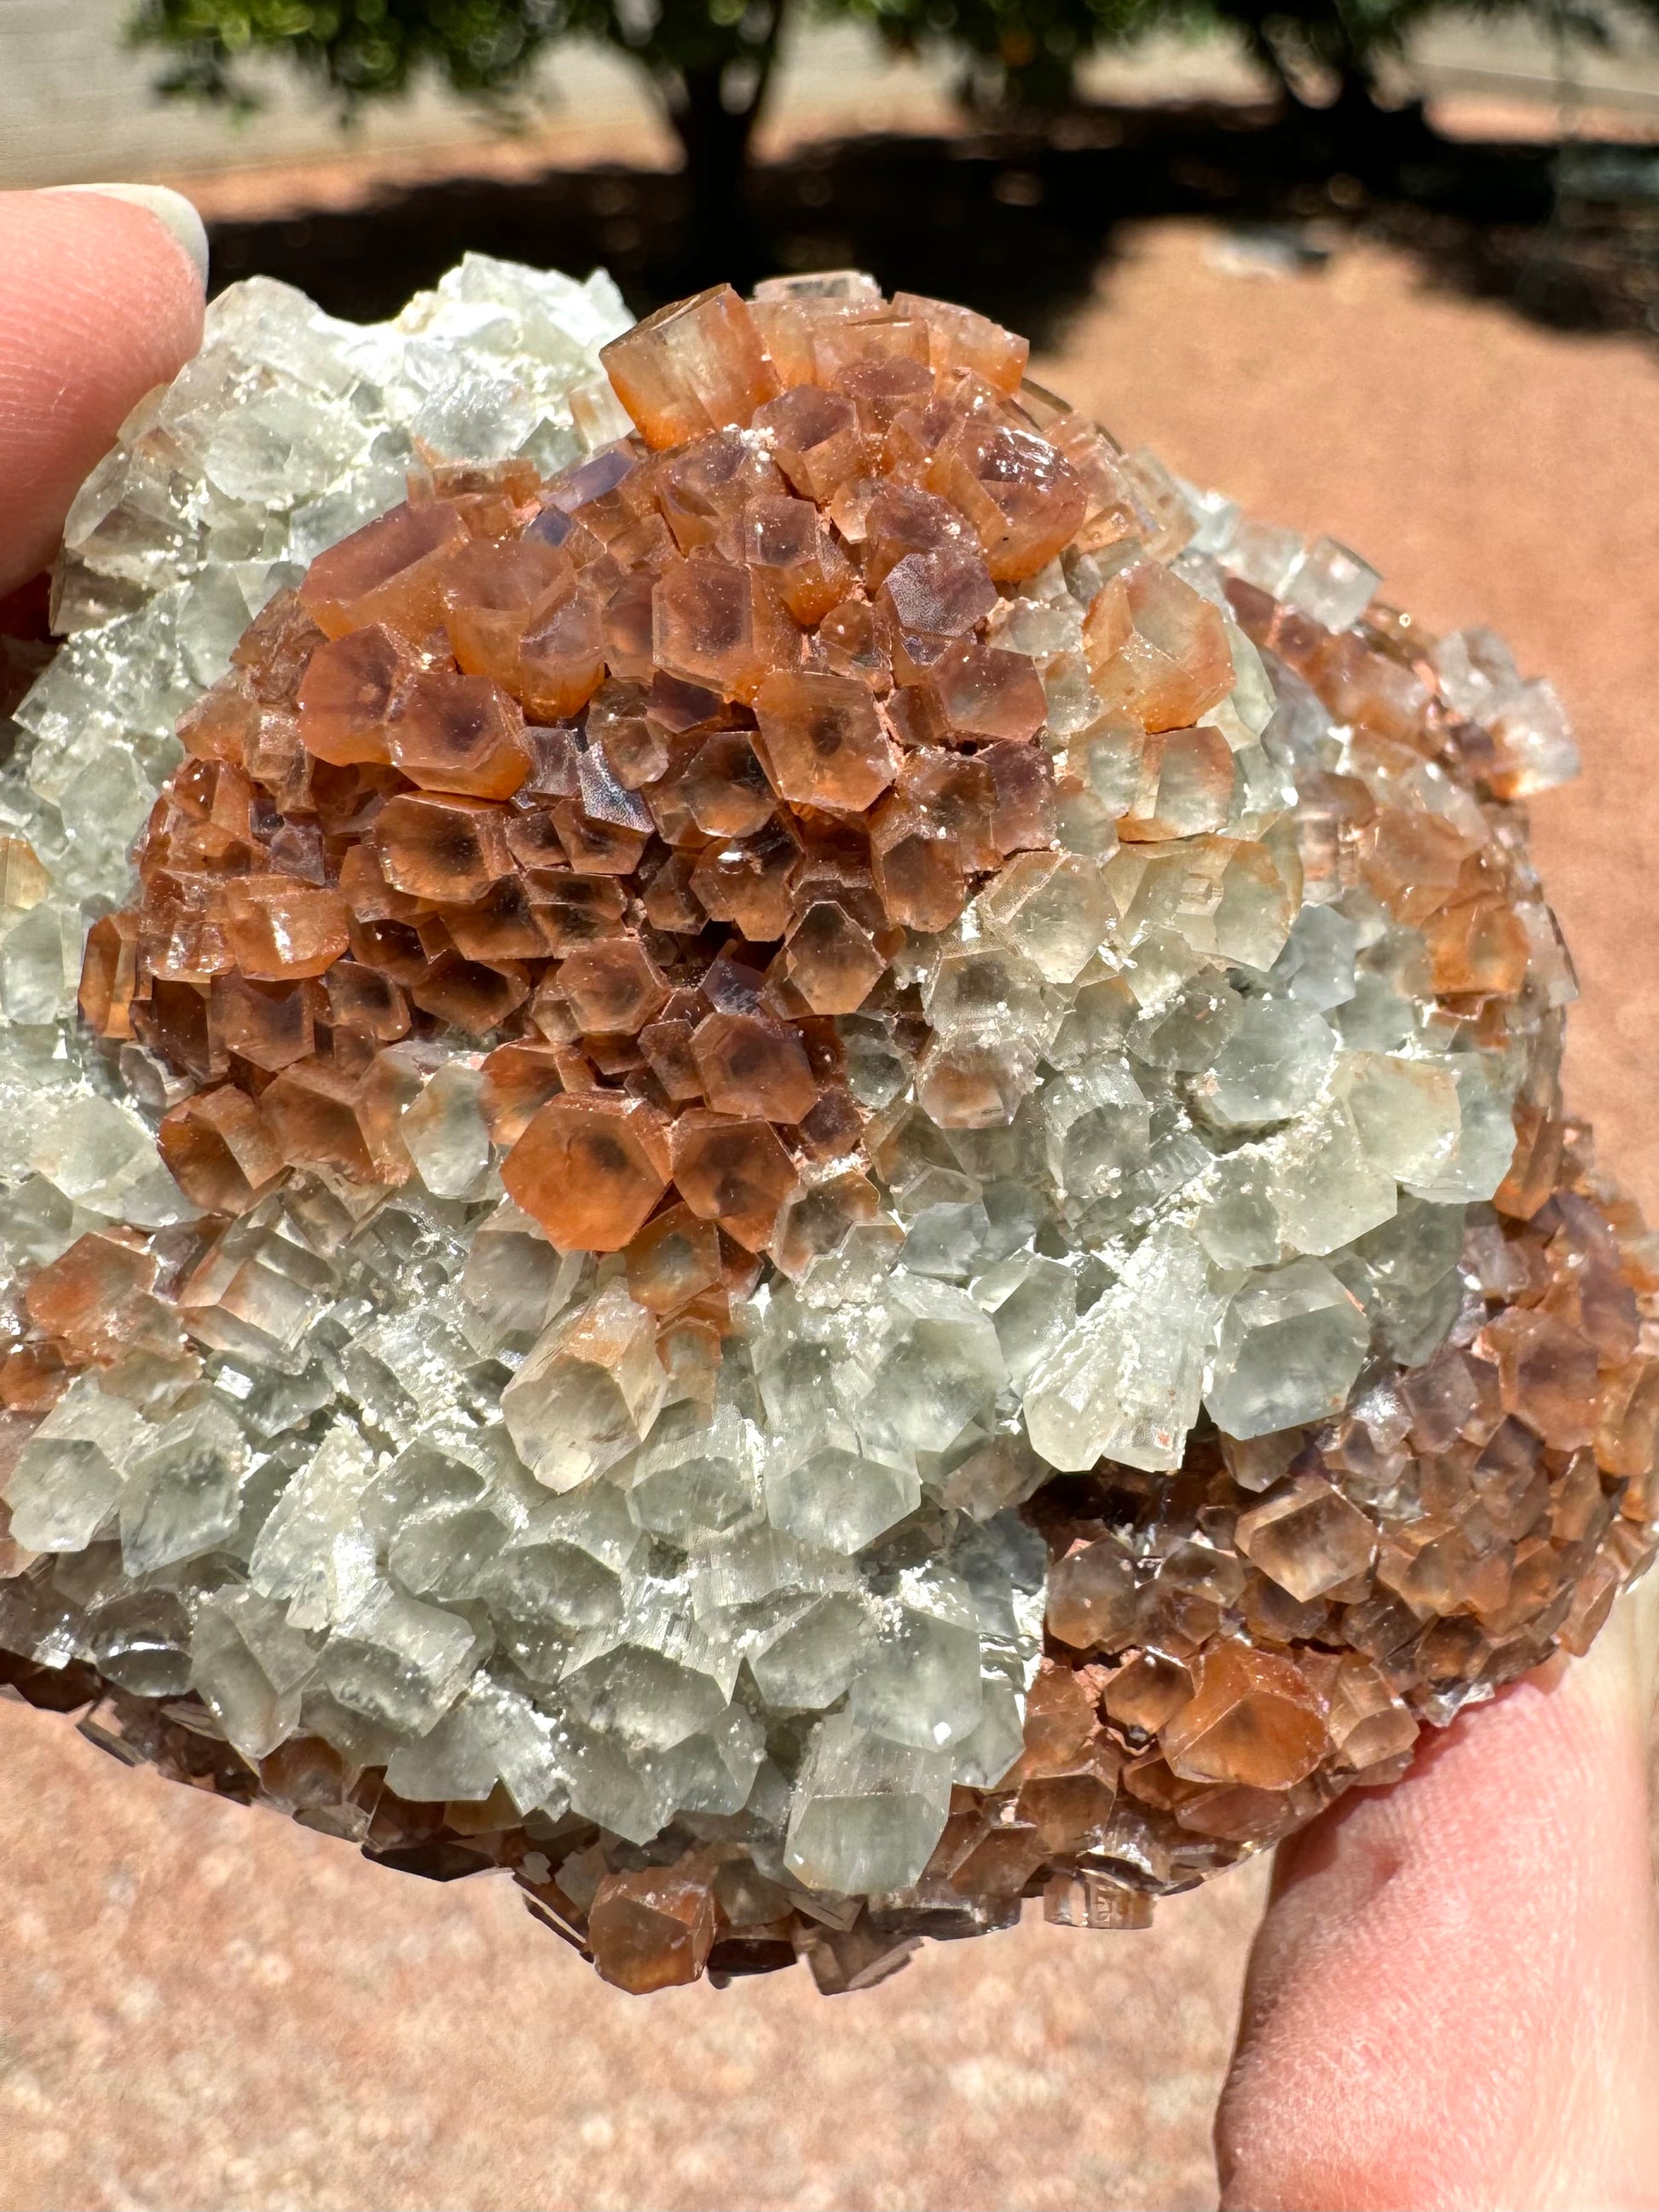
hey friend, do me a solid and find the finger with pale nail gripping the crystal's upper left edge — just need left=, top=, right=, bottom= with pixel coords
left=0, top=186, right=205, bottom=597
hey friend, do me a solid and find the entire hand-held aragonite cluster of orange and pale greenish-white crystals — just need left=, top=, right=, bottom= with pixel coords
left=0, top=258, right=1659, bottom=1991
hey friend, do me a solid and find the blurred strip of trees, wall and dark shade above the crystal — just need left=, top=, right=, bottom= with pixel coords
left=0, top=0, right=1659, bottom=339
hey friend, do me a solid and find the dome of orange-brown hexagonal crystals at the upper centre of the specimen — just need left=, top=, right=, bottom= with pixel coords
left=82, top=281, right=1232, bottom=1314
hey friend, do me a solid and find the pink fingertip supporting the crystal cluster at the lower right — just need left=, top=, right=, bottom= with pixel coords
left=1217, top=1575, right=1659, bottom=2212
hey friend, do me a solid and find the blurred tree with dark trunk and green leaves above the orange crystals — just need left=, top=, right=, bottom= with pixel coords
left=128, top=0, right=789, bottom=272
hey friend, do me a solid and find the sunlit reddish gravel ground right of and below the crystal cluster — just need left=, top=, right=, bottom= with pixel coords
left=0, top=211, right=1659, bottom=2212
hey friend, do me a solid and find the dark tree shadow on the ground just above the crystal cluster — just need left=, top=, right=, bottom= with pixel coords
left=212, top=107, right=1659, bottom=345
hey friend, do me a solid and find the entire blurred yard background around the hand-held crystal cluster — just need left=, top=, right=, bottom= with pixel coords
left=0, top=0, right=1659, bottom=2212
